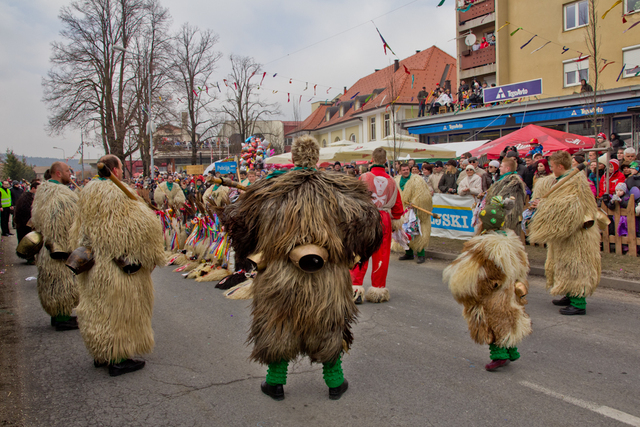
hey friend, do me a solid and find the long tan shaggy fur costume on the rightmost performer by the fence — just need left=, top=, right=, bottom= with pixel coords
left=528, top=173, right=601, bottom=298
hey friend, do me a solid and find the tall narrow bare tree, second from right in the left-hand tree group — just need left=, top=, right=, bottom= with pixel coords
left=170, top=23, right=222, bottom=164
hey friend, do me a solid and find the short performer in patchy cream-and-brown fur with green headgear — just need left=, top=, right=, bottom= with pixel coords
left=442, top=196, right=531, bottom=371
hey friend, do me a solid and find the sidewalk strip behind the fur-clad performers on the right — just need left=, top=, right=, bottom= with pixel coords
left=425, top=236, right=640, bottom=293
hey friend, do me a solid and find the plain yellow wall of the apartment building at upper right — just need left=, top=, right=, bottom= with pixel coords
left=496, top=0, right=640, bottom=97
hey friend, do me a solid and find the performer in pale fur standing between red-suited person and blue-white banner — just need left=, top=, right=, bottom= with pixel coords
left=395, top=163, right=433, bottom=264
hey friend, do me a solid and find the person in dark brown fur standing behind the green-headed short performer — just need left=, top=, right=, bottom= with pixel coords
left=485, top=156, right=527, bottom=234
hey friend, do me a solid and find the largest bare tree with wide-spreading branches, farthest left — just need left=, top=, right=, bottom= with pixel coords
left=42, top=0, right=146, bottom=166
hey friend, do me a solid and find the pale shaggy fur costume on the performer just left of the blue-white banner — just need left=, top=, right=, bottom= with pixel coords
left=391, top=174, right=433, bottom=253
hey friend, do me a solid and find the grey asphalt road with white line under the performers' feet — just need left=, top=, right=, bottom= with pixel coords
left=0, top=239, right=640, bottom=427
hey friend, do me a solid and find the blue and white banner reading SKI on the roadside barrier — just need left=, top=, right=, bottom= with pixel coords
left=431, top=193, right=476, bottom=240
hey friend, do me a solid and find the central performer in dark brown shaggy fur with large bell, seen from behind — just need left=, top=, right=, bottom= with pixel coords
left=223, top=135, right=382, bottom=400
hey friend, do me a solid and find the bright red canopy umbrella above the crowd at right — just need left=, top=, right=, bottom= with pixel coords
left=470, top=125, right=596, bottom=159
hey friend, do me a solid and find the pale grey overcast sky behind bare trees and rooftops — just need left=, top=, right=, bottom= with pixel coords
left=0, top=0, right=455, bottom=158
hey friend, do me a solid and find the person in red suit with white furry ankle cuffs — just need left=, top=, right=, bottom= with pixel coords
left=351, top=147, right=404, bottom=304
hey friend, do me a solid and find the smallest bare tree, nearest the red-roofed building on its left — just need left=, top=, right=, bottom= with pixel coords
left=222, top=54, right=280, bottom=145
